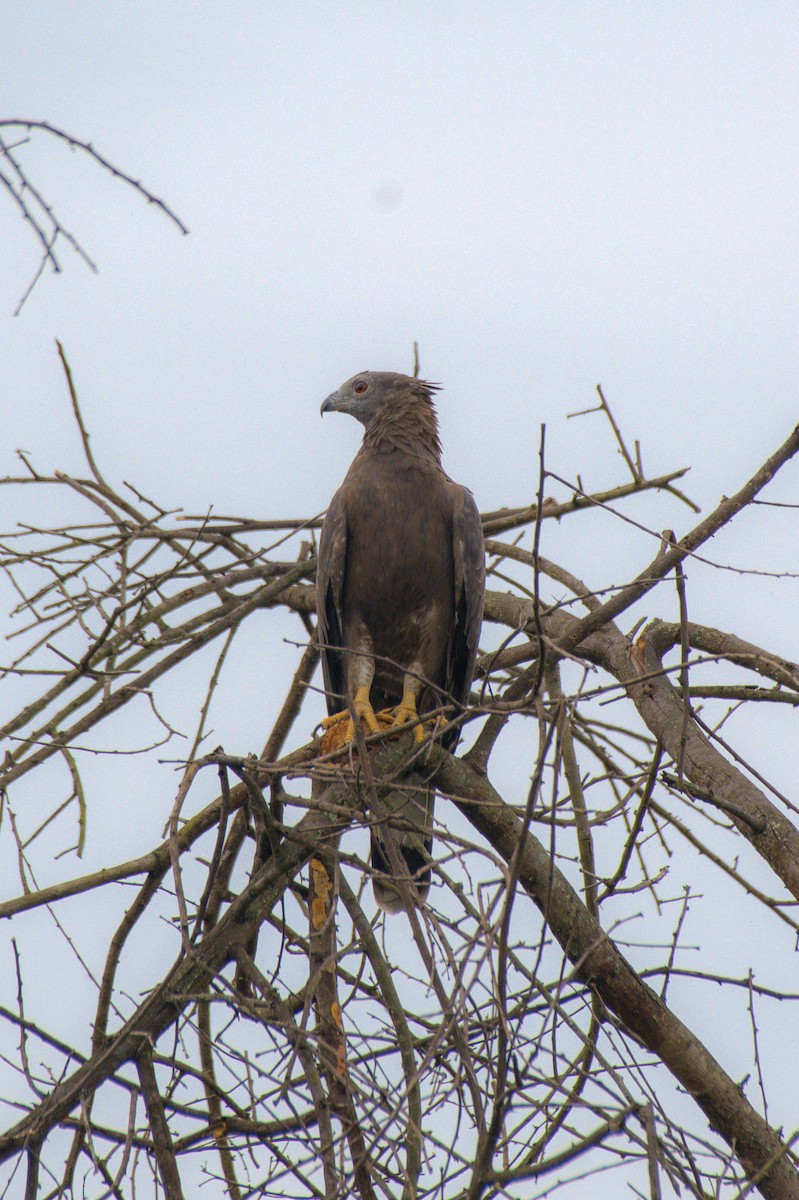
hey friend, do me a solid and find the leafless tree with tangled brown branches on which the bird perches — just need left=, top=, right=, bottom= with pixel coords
left=0, top=347, right=799, bottom=1200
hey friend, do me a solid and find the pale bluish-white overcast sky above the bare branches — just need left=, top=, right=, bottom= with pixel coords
left=0, top=0, right=799, bottom=1195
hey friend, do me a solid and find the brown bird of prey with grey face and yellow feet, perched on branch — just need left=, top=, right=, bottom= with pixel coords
left=317, top=371, right=485, bottom=912
